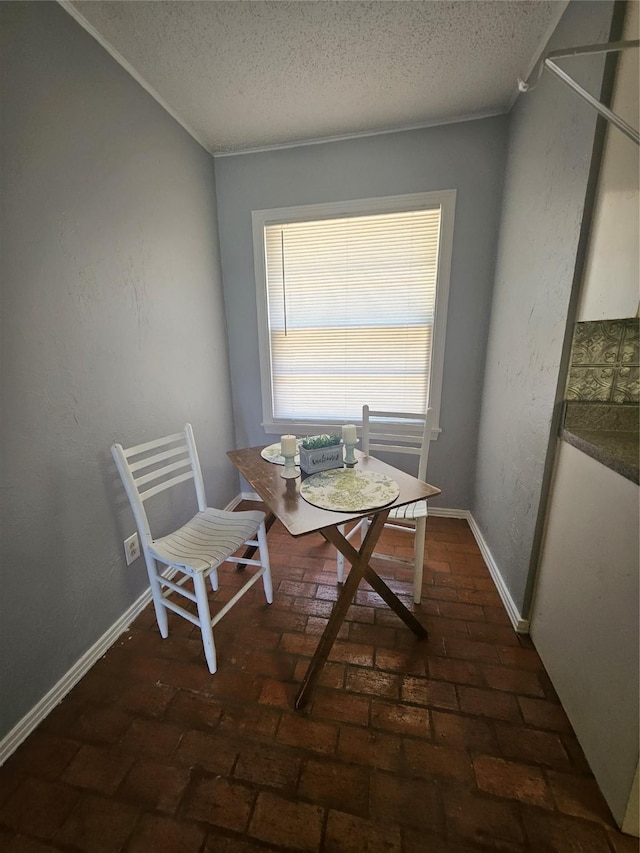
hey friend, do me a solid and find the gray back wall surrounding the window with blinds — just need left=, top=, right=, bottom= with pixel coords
left=215, top=117, right=507, bottom=509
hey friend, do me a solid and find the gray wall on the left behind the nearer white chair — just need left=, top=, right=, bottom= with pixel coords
left=0, top=3, right=237, bottom=737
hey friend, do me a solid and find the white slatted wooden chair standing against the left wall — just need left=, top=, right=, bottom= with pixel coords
left=111, top=424, right=273, bottom=673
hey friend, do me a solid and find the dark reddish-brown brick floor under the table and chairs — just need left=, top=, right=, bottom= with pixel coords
left=0, top=510, right=638, bottom=853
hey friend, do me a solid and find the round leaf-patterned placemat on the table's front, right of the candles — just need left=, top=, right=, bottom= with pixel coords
left=300, top=468, right=400, bottom=512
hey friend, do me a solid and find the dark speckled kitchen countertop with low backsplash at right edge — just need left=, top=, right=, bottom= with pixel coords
left=560, top=401, right=640, bottom=483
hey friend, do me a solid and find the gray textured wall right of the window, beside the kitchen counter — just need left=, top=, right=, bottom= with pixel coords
left=472, top=2, right=613, bottom=615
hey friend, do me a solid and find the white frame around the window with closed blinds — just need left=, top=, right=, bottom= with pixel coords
left=251, top=190, right=456, bottom=439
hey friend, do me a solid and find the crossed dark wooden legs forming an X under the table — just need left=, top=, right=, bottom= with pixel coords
left=294, top=510, right=427, bottom=709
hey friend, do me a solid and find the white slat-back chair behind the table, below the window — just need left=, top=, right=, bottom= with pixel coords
left=336, top=406, right=431, bottom=604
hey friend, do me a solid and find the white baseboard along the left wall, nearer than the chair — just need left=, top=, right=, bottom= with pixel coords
left=0, top=589, right=151, bottom=766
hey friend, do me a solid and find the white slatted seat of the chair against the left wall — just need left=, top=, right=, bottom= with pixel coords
left=149, top=508, right=264, bottom=572
